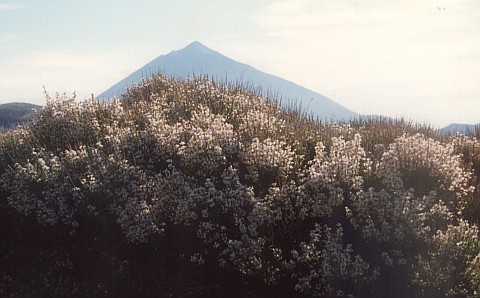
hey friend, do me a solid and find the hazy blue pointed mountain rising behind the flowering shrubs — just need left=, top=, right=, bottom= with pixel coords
left=97, top=42, right=358, bottom=121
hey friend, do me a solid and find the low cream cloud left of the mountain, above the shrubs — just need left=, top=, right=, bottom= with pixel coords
left=0, top=46, right=145, bottom=104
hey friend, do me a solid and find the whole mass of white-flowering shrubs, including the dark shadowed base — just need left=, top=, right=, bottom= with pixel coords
left=0, top=76, right=480, bottom=297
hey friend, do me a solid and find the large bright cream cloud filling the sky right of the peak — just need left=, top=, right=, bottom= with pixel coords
left=238, top=0, right=480, bottom=126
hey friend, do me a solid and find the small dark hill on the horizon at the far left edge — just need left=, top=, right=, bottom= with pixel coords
left=0, top=102, right=42, bottom=129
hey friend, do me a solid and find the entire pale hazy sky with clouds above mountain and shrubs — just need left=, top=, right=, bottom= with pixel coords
left=0, top=0, right=480, bottom=127
